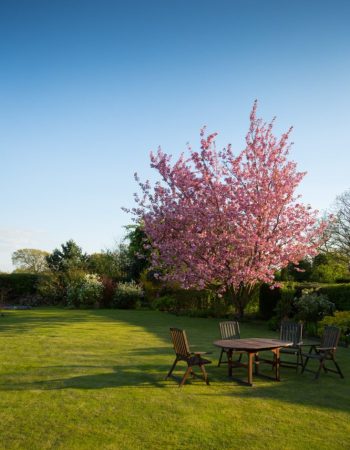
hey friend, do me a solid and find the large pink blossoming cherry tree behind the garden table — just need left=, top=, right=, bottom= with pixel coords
left=132, top=102, right=327, bottom=316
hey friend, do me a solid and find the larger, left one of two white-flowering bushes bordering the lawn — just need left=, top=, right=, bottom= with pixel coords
left=67, top=274, right=103, bottom=308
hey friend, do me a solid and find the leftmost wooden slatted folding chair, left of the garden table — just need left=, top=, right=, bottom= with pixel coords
left=165, top=328, right=211, bottom=387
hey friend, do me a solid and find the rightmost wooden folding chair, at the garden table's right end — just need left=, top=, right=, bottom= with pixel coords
left=301, top=326, right=344, bottom=379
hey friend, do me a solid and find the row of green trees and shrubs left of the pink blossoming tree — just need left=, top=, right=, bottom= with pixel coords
left=0, top=226, right=147, bottom=307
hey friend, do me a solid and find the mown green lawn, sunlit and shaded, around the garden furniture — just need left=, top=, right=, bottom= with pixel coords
left=0, top=309, right=350, bottom=450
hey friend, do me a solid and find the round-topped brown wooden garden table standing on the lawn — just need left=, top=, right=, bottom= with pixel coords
left=214, top=338, right=293, bottom=386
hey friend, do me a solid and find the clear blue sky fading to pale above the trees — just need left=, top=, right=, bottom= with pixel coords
left=0, top=0, right=350, bottom=270
